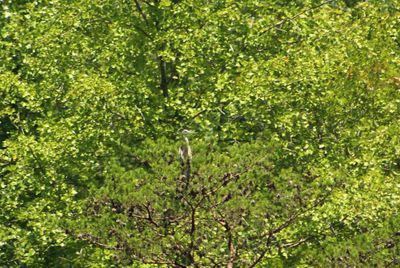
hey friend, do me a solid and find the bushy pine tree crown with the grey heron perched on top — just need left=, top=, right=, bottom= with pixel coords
left=74, top=140, right=330, bottom=267
